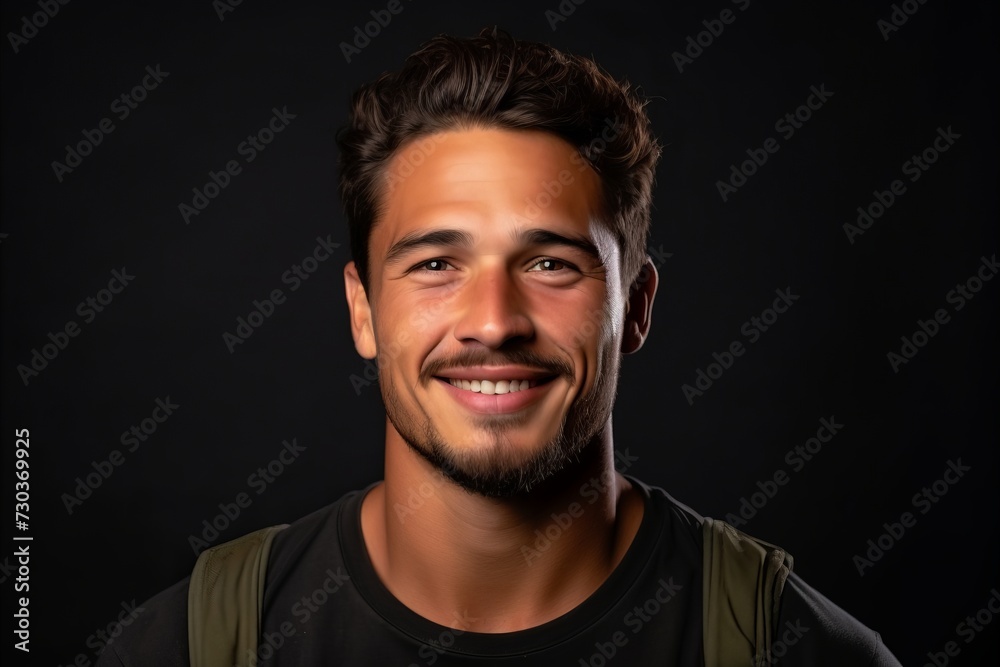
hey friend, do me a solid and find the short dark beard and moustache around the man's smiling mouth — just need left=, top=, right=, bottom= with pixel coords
left=379, top=345, right=621, bottom=498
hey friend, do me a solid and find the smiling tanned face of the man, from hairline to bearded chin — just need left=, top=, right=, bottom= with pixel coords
left=348, top=129, right=625, bottom=497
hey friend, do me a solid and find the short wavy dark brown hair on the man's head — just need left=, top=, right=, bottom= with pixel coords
left=338, top=28, right=660, bottom=289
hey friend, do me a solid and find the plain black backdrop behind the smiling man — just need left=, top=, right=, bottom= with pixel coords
left=0, top=0, right=1000, bottom=665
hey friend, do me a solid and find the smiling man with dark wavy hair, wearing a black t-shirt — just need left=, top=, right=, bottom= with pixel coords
left=99, top=30, right=898, bottom=667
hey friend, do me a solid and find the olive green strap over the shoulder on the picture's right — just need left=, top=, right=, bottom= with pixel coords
left=702, top=518, right=792, bottom=667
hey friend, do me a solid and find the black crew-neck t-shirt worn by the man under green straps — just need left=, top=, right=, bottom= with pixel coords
left=98, top=480, right=899, bottom=667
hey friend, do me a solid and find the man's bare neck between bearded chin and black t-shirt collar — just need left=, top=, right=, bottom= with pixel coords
left=362, top=423, right=643, bottom=632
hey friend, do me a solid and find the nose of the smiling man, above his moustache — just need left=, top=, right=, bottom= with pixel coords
left=455, top=263, right=535, bottom=349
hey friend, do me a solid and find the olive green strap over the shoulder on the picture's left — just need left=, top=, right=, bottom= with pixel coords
left=188, top=524, right=287, bottom=667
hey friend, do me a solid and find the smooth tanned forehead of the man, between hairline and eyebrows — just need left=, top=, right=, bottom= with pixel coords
left=370, top=128, right=600, bottom=252
